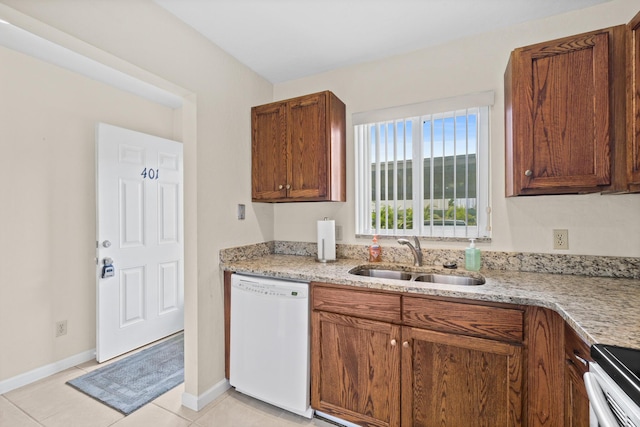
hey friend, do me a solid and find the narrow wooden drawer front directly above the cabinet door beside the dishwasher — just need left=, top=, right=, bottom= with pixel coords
left=312, top=286, right=401, bottom=323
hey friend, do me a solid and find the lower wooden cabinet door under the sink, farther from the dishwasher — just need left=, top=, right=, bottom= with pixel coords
left=402, top=327, right=523, bottom=427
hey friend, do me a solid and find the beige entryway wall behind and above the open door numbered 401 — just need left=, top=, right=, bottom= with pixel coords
left=0, top=44, right=173, bottom=380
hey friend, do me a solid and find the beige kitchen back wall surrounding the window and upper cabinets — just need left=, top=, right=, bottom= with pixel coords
left=274, top=0, right=640, bottom=257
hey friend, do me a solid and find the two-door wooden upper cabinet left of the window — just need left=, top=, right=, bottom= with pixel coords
left=251, top=91, right=346, bottom=202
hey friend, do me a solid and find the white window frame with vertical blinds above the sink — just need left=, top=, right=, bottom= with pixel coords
left=352, top=91, right=494, bottom=241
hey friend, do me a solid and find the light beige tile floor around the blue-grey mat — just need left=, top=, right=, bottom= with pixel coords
left=0, top=350, right=335, bottom=427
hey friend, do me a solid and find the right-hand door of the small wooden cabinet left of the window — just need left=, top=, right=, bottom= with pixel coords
left=286, top=93, right=329, bottom=199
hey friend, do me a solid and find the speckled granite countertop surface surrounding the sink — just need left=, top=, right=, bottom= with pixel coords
left=221, top=255, right=640, bottom=349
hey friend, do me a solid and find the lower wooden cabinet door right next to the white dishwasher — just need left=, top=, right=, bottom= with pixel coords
left=311, top=311, right=400, bottom=427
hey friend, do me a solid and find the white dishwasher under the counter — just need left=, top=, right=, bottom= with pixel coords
left=229, top=274, right=313, bottom=418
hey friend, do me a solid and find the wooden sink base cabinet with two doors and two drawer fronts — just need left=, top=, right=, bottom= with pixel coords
left=311, top=285, right=525, bottom=427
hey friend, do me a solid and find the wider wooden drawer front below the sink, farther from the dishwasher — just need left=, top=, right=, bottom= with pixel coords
left=402, top=297, right=524, bottom=341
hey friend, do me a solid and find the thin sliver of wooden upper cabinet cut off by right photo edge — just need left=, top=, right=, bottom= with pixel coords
left=627, top=13, right=640, bottom=192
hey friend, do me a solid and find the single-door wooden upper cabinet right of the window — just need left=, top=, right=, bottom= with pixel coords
left=505, top=25, right=626, bottom=196
